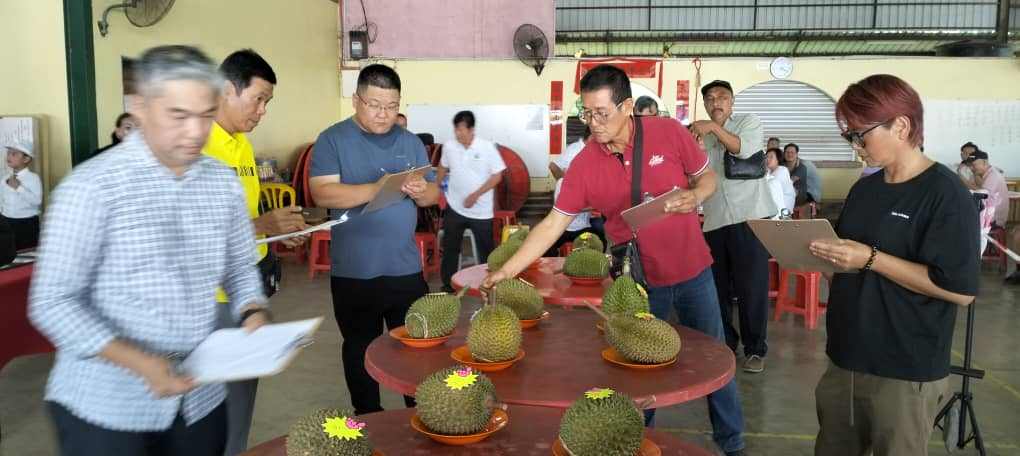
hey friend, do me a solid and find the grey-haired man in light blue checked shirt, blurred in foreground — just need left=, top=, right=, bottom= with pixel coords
left=29, top=46, right=268, bottom=456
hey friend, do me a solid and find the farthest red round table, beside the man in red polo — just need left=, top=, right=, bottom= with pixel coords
left=451, top=257, right=613, bottom=306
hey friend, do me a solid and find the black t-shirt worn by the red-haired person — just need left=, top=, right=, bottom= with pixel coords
left=825, top=163, right=980, bottom=382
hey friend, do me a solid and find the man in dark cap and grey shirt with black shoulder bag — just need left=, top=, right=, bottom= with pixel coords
left=691, top=81, right=778, bottom=372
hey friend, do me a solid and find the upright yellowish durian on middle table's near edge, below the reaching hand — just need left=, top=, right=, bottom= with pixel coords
left=467, top=303, right=521, bottom=362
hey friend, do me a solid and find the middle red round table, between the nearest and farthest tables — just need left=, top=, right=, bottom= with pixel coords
left=365, top=305, right=735, bottom=408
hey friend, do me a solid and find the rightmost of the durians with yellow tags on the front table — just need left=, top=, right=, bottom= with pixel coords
left=560, top=388, right=645, bottom=456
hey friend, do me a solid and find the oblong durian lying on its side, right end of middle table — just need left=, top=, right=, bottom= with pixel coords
left=606, top=313, right=680, bottom=364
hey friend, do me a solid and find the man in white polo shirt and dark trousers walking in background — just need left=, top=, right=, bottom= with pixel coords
left=437, top=111, right=506, bottom=292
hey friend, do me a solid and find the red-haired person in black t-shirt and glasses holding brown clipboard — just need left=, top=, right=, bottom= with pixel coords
left=811, top=74, right=979, bottom=456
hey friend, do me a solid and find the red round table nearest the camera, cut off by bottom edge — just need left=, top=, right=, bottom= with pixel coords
left=242, top=406, right=712, bottom=456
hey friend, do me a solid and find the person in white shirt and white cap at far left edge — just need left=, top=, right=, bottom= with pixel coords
left=0, top=143, right=43, bottom=250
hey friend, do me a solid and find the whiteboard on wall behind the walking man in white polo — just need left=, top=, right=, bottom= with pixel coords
left=407, top=104, right=549, bottom=178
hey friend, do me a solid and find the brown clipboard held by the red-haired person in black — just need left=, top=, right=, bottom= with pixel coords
left=748, top=218, right=856, bottom=273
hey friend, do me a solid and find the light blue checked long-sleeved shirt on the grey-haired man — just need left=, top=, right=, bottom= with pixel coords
left=29, top=133, right=265, bottom=432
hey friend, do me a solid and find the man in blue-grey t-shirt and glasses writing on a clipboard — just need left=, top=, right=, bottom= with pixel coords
left=309, top=64, right=440, bottom=415
